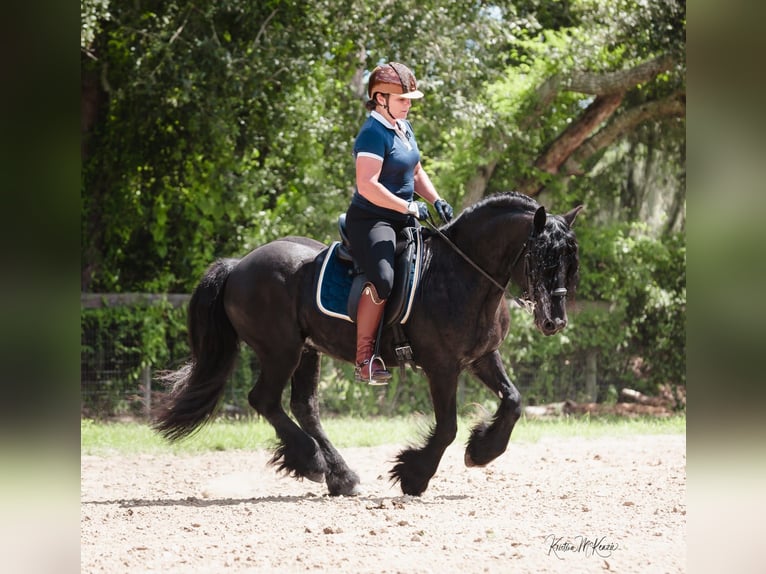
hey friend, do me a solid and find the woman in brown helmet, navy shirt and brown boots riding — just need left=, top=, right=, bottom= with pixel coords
left=346, top=62, right=453, bottom=384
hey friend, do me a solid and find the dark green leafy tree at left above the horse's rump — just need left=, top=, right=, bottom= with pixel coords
left=82, top=0, right=366, bottom=291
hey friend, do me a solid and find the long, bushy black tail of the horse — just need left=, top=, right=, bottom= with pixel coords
left=152, top=259, right=239, bottom=441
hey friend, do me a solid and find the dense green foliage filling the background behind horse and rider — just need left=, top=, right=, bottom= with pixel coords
left=81, top=0, right=686, bottom=414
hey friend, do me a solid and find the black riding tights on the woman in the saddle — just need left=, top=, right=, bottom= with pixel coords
left=346, top=205, right=417, bottom=299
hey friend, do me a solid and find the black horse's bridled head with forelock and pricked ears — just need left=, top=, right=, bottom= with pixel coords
left=523, top=206, right=582, bottom=335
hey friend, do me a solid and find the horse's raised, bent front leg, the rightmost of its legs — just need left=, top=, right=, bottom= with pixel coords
left=465, top=351, right=521, bottom=466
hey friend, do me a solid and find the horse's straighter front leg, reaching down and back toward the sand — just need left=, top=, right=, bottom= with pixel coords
left=391, top=369, right=458, bottom=496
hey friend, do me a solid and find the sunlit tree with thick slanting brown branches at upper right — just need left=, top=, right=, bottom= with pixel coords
left=450, top=2, right=686, bottom=231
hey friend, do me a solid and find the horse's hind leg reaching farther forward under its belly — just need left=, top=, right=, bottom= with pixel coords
left=290, top=349, right=359, bottom=496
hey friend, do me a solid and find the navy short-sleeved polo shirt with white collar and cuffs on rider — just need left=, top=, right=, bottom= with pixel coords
left=351, top=112, right=420, bottom=220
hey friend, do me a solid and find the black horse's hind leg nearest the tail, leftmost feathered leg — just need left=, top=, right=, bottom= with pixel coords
left=248, top=349, right=327, bottom=482
